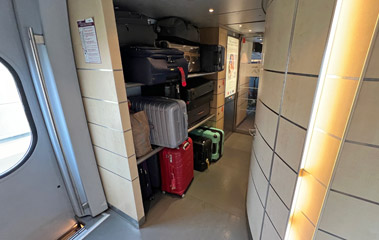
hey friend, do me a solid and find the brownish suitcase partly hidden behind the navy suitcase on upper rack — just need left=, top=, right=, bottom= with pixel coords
left=156, top=40, right=200, bottom=73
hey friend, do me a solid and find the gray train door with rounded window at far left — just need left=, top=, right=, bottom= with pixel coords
left=0, top=0, right=76, bottom=239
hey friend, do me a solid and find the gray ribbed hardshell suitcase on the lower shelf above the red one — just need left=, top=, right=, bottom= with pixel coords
left=129, top=97, right=188, bottom=148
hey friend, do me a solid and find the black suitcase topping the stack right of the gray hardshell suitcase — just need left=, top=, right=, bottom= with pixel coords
left=182, top=78, right=213, bottom=101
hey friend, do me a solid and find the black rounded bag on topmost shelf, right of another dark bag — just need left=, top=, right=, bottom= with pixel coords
left=157, top=17, right=200, bottom=45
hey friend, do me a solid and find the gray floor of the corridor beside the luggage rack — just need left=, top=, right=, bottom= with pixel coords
left=86, top=133, right=252, bottom=240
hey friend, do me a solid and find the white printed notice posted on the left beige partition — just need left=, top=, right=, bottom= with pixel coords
left=77, top=18, right=101, bottom=63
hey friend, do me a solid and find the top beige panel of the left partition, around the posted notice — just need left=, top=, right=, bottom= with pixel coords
left=68, top=0, right=122, bottom=69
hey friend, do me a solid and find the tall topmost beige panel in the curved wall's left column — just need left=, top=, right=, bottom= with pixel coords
left=263, top=0, right=295, bottom=72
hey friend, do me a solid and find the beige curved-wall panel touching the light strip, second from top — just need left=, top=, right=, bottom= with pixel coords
left=282, top=75, right=317, bottom=128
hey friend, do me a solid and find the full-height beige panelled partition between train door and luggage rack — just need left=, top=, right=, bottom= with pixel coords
left=68, top=0, right=144, bottom=226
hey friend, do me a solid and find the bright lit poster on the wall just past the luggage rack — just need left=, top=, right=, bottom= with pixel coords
left=225, top=37, right=239, bottom=98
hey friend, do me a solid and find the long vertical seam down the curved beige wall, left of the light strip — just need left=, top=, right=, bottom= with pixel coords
left=259, top=0, right=299, bottom=240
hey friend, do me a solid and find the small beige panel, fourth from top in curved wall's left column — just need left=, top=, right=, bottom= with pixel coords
left=253, top=132, right=273, bottom=178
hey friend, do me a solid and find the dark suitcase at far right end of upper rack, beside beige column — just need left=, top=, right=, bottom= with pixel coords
left=200, top=45, right=225, bottom=72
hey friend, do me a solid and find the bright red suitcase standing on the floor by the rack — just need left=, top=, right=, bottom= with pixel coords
left=159, top=138, right=193, bottom=197
